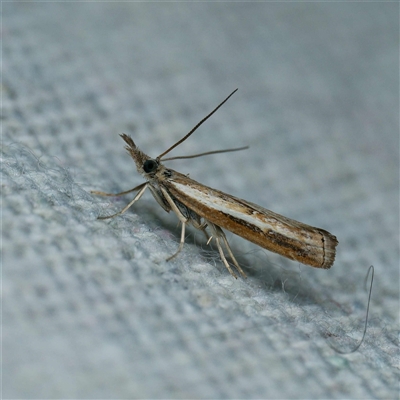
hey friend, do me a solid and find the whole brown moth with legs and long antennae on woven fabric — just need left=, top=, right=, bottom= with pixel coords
left=92, top=89, right=338, bottom=278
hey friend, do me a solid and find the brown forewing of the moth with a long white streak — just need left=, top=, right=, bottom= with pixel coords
left=163, top=170, right=338, bottom=269
